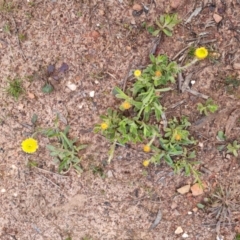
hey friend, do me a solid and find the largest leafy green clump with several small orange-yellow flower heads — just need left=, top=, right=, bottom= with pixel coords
left=94, top=55, right=200, bottom=182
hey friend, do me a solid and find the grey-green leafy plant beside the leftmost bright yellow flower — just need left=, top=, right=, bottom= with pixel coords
left=40, top=126, right=87, bottom=173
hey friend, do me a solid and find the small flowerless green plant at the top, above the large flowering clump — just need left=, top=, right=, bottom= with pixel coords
left=150, top=14, right=180, bottom=37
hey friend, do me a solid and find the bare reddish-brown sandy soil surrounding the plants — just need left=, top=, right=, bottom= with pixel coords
left=0, top=0, right=240, bottom=240
